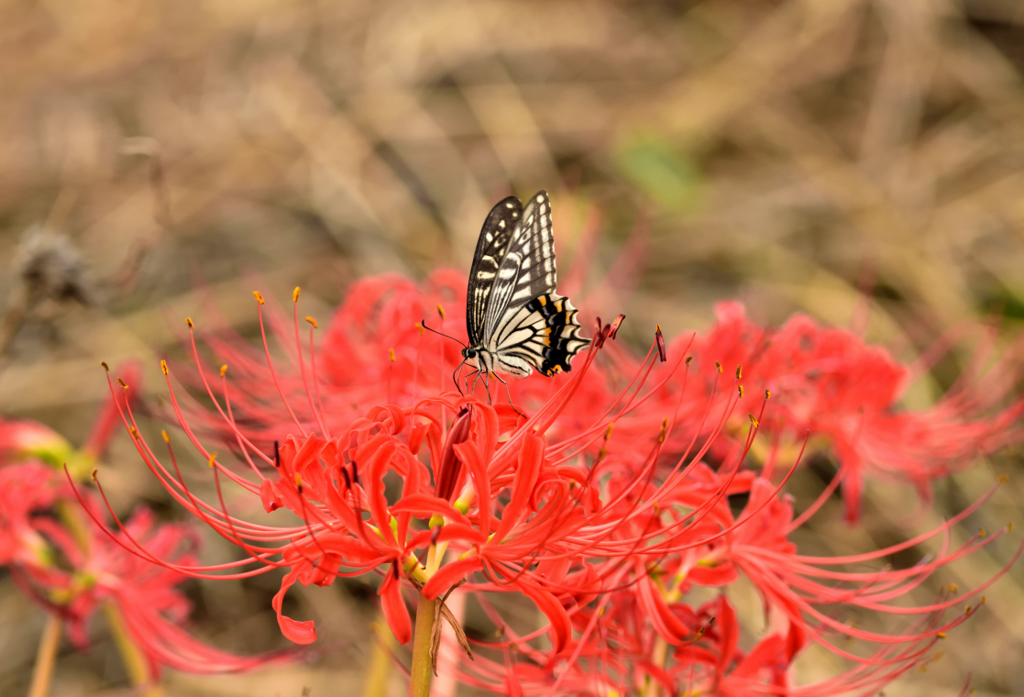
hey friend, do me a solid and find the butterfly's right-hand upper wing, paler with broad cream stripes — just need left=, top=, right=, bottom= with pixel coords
left=481, top=191, right=557, bottom=345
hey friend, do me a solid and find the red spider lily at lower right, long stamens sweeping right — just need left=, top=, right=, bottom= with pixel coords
left=454, top=472, right=1024, bottom=697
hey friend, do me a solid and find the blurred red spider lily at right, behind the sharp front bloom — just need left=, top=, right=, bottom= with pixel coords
left=623, top=302, right=1024, bottom=521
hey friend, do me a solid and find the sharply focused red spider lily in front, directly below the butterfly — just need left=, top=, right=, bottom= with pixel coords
left=96, top=303, right=742, bottom=651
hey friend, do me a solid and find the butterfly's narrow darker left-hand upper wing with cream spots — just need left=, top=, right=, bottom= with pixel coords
left=466, top=197, right=522, bottom=346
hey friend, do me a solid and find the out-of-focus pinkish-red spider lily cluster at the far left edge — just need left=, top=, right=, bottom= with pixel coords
left=0, top=405, right=288, bottom=676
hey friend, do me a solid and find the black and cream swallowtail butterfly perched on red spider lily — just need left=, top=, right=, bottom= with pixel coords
left=462, top=191, right=589, bottom=382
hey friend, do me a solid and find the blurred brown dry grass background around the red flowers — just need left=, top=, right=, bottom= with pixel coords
left=0, top=0, right=1024, bottom=697
